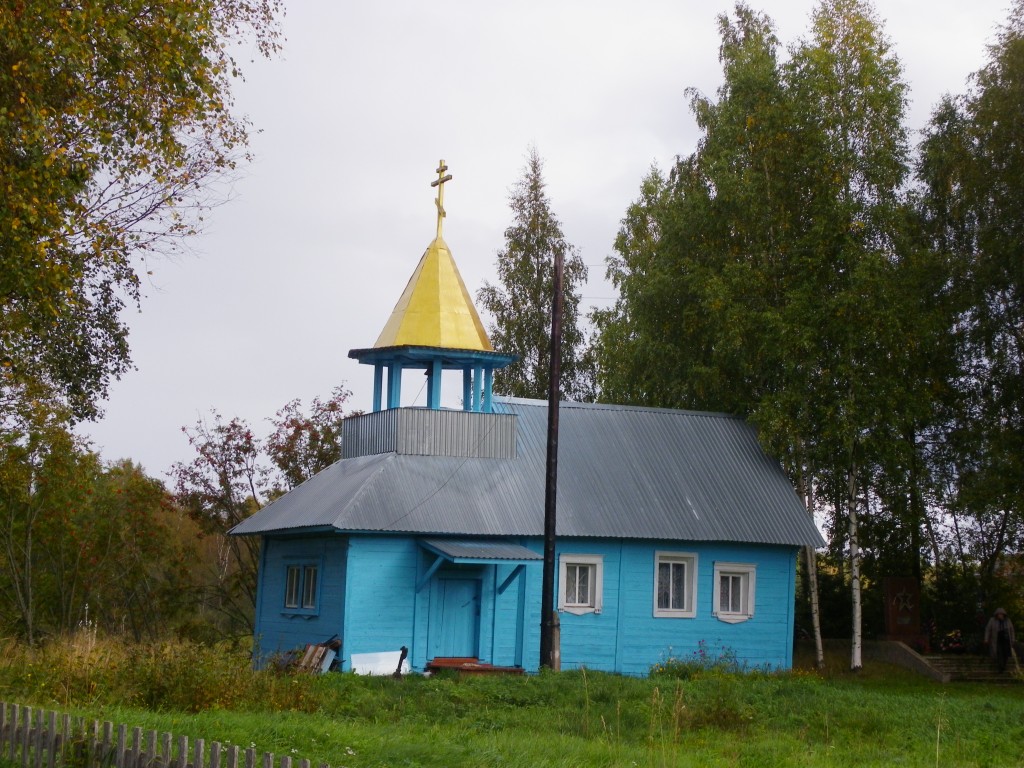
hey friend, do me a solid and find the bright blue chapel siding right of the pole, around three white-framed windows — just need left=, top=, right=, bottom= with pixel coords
left=558, top=540, right=796, bottom=675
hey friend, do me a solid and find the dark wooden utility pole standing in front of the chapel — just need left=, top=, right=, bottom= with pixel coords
left=541, top=249, right=562, bottom=670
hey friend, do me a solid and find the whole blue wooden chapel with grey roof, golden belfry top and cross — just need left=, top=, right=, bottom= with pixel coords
left=231, top=161, right=822, bottom=675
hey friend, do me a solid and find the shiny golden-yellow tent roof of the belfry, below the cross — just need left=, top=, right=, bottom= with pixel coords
left=374, top=236, right=493, bottom=352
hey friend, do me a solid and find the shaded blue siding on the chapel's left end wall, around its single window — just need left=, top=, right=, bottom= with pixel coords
left=255, top=536, right=346, bottom=665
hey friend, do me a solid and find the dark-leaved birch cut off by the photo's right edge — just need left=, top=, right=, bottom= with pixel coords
left=920, top=0, right=1024, bottom=608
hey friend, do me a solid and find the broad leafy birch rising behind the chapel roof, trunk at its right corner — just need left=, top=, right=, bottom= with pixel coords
left=596, top=5, right=823, bottom=664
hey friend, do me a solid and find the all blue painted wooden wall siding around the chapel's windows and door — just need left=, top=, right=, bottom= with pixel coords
left=251, top=535, right=797, bottom=675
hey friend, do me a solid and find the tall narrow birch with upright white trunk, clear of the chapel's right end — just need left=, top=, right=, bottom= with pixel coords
left=774, top=0, right=912, bottom=670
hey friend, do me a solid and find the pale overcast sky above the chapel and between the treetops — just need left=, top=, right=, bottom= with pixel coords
left=80, top=0, right=1008, bottom=477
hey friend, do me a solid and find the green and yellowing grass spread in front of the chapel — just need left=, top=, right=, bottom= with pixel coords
left=0, top=637, right=1024, bottom=768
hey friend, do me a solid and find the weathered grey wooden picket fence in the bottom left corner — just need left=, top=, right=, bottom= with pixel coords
left=0, top=702, right=329, bottom=768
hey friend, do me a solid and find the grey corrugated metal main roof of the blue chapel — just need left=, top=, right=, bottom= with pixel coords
left=232, top=399, right=823, bottom=546
